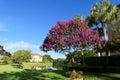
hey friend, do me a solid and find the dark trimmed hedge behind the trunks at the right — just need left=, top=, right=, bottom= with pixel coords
left=85, top=55, right=120, bottom=66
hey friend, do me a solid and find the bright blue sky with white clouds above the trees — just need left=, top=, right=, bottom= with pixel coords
left=0, top=0, right=120, bottom=58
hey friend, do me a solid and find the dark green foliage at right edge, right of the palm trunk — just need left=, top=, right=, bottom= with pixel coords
left=105, top=20, right=120, bottom=52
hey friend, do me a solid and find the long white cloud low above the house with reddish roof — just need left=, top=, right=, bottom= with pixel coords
left=4, top=41, right=39, bottom=51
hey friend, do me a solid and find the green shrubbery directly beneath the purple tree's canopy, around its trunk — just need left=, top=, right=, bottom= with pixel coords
left=65, top=50, right=96, bottom=67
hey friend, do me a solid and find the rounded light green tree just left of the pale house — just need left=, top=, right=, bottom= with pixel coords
left=13, top=50, right=31, bottom=64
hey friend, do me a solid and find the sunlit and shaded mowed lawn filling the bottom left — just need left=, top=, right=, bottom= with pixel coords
left=0, top=65, right=68, bottom=80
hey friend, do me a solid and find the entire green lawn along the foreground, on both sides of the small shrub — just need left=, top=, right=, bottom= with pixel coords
left=0, top=63, right=120, bottom=80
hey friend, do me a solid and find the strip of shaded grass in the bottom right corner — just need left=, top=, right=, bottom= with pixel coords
left=84, top=72, right=120, bottom=80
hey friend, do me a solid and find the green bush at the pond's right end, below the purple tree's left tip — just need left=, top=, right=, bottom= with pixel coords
left=53, top=58, right=66, bottom=69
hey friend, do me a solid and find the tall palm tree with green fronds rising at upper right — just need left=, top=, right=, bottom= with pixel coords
left=87, top=0, right=120, bottom=40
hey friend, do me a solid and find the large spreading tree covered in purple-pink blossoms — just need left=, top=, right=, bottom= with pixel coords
left=40, top=19, right=102, bottom=66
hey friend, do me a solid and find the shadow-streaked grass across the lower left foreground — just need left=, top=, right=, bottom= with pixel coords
left=0, top=69, right=67, bottom=80
